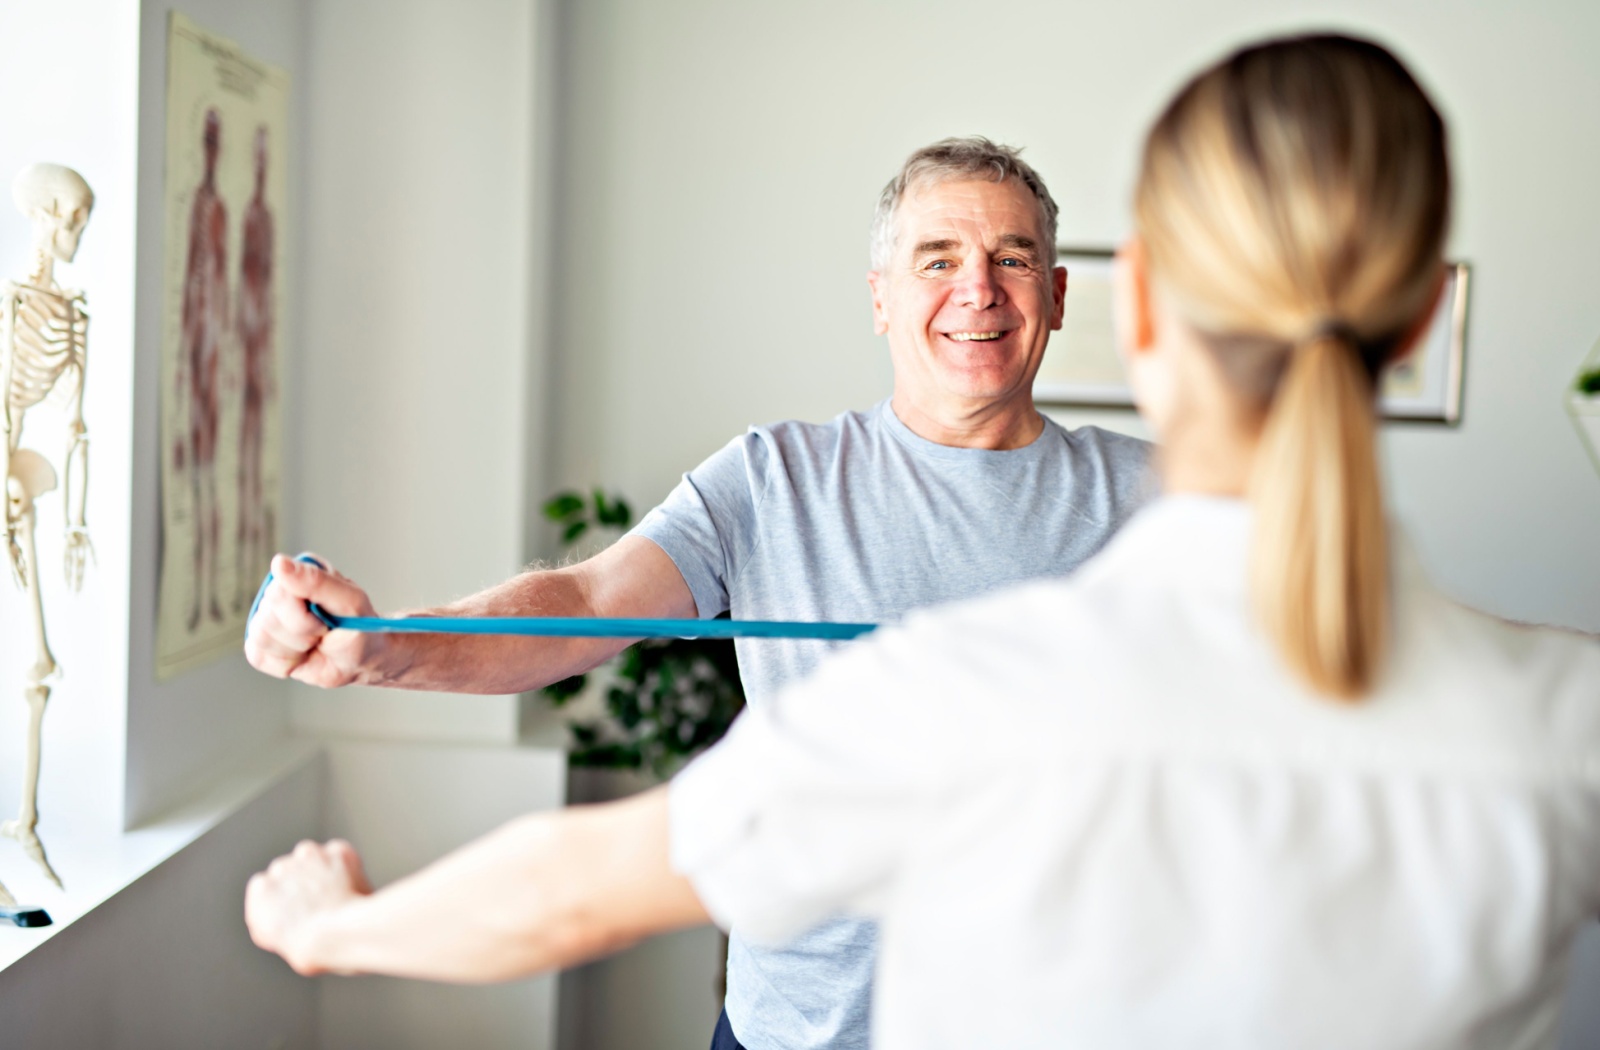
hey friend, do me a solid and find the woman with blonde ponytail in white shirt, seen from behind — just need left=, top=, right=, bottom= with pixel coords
left=246, top=37, right=1600, bottom=1050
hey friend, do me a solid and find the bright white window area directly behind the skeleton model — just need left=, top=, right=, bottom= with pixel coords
left=0, top=0, right=138, bottom=864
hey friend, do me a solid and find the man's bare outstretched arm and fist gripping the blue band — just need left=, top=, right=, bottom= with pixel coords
left=245, top=536, right=696, bottom=693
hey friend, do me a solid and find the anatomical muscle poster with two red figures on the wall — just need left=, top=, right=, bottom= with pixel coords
left=155, top=11, right=290, bottom=680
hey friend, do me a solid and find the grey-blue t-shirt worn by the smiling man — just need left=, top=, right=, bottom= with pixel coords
left=634, top=402, right=1154, bottom=1050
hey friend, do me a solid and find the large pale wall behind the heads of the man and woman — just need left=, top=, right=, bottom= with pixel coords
left=550, top=0, right=1600, bottom=1047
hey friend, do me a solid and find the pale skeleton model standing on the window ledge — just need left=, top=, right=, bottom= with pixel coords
left=0, top=163, right=94, bottom=906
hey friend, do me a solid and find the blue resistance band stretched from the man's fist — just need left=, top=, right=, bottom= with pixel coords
left=245, top=554, right=877, bottom=640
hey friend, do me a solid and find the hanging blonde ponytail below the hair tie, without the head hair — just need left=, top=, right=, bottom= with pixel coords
left=1250, top=331, right=1389, bottom=699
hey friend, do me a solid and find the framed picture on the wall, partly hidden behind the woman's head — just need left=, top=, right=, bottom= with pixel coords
left=1034, top=248, right=1470, bottom=423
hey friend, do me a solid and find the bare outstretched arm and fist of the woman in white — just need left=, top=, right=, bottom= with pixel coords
left=245, top=786, right=709, bottom=983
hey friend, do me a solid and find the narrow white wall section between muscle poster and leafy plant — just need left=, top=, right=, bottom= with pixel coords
left=294, top=0, right=542, bottom=741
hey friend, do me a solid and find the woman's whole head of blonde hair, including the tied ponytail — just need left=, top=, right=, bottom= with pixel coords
left=1134, top=35, right=1450, bottom=699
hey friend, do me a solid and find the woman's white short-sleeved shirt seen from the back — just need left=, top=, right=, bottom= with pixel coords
left=670, top=498, right=1600, bottom=1050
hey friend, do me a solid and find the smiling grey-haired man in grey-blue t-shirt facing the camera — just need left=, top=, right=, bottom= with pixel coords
left=246, top=138, right=1149, bottom=1050
